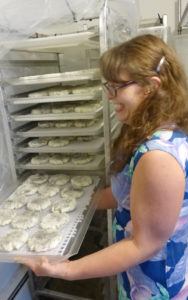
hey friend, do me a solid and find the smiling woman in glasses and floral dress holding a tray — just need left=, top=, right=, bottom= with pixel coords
left=19, top=35, right=188, bottom=300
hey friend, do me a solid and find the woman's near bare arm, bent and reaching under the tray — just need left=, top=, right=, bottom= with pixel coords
left=18, top=150, right=185, bottom=280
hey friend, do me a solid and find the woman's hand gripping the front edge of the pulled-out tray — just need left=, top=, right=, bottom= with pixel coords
left=17, top=256, right=69, bottom=279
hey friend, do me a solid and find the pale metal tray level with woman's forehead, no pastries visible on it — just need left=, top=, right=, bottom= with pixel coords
left=4, top=68, right=100, bottom=86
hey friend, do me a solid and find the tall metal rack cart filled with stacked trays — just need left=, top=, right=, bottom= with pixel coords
left=0, top=1, right=122, bottom=300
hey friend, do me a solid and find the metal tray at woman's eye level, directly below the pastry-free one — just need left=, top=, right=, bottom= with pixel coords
left=7, top=91, right=101, bottom=104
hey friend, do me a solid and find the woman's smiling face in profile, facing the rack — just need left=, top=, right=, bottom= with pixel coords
left=107, top=76, right=146, bottom=125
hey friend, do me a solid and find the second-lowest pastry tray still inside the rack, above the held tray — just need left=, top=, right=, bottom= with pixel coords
left=15, top=137, right=104, bottom=153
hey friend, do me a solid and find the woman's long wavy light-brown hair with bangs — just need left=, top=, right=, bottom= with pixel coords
left=100, top=34, right=188, bottom=173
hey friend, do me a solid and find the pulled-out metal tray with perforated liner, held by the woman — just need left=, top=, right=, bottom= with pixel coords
left=0, top=176, right=101, bottom=262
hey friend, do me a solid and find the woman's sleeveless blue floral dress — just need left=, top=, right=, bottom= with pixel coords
left=111, top=130, right=188, bottom=300
